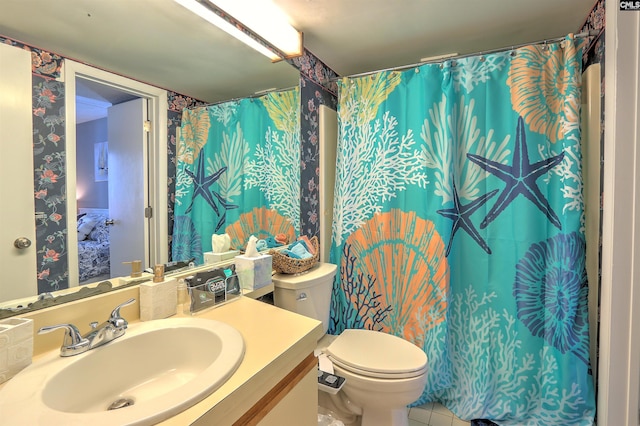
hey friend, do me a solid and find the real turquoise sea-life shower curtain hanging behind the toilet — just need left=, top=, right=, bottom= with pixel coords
left=330, top=36, right=595, bottom=426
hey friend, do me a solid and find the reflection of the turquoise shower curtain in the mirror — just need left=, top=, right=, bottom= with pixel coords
left=172, top=88, right=300, bottom=264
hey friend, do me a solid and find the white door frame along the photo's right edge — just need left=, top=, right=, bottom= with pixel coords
left=597, top=2, right=640, bottom=426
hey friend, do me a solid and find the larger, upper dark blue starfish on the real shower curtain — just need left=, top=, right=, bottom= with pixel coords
left=467, top=117, right=564, bottom=229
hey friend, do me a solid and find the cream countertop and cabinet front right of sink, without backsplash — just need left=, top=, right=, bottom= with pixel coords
left=160, top=297, right=322, bottom=426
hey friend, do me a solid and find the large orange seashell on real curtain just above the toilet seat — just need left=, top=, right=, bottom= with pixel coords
left=346, top=209, right=449, bottom=343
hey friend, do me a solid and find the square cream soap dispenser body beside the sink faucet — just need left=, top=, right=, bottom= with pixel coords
left=140, top=279, right=178, bottom=321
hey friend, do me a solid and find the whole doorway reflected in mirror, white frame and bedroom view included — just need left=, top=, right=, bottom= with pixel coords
left=65, top=61, right=168, bottom=287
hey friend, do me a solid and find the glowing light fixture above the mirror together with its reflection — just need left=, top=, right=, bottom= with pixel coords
left=175, top=0, right=302, bottom=61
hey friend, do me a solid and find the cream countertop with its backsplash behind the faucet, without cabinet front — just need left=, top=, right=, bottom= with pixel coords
left=0, top=288, right=322, bottom=426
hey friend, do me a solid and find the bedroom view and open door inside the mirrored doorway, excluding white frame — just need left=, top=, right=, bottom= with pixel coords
left=75, top=77, right=143, bottom=284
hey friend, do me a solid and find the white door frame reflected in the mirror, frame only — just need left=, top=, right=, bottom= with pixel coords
left=64, top=59, right=169, bottom=287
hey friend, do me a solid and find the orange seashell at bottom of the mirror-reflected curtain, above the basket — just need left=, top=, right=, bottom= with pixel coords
left=225, top=207, right=296, bottom=249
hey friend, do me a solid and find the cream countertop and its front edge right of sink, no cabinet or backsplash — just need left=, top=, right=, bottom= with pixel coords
left=160, top=297, right=322, bottom=426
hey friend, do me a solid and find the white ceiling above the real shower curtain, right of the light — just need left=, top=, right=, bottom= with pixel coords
left=282, top=0, right=595, bottom=75
